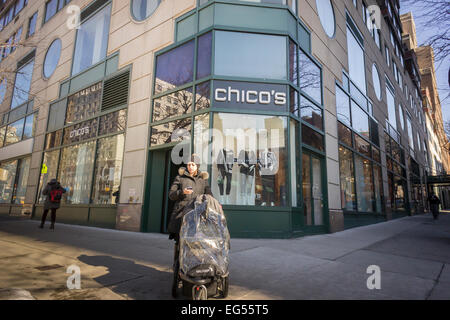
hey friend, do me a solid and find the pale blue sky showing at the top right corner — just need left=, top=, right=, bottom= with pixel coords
left=400, top=0, right=450, bottom=125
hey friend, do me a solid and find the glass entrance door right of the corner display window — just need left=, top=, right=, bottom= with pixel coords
left=302, top=152, right=325, bottom=226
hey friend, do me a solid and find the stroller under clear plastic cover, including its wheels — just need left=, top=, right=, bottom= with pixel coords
left=172, top=195, right=230, bottom=300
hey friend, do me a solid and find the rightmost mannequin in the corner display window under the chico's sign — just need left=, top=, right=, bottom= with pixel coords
left=258, top=148, right=278, bottom=207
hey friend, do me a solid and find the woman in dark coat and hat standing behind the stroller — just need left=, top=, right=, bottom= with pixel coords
left=168, top=154, right=213, bottom=242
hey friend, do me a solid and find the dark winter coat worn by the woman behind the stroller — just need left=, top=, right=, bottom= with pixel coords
left=168, top=168, right=213, bottom=234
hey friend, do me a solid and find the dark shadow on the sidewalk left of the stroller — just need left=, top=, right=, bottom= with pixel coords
left=78, top=255, right=176, bottom=300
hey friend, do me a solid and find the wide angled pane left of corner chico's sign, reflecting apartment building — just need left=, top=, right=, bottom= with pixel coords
left=152, top=88, right=192, bottom=122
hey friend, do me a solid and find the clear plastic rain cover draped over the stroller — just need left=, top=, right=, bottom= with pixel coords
left=180, top=195, right=230, bottom=278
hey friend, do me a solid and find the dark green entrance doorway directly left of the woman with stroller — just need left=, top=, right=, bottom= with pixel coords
left=147, top=149, right=182, bottom=233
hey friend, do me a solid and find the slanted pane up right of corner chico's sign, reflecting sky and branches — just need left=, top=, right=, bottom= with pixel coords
left=298, top=50, right=322, bottom=104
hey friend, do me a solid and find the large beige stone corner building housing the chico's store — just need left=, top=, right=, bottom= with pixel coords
left=0, top=0, right=428, bottom=238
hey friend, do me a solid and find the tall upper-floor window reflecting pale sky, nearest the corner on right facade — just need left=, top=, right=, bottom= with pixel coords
left=347, top=27, right=367, bottom=94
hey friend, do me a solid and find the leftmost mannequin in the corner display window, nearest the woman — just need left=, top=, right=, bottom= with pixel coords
left=238, top=149, right=257, bottom=205
